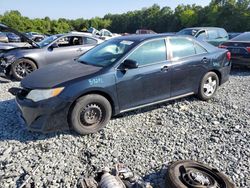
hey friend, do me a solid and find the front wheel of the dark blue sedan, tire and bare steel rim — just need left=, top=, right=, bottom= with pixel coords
left=69, top=94, right=112, bottom=135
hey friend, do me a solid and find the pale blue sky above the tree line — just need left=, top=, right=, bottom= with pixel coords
left=0, top=0, right=210, bottom=19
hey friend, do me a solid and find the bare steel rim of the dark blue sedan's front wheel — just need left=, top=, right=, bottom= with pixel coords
left=80, top=104, right=103, bottom=126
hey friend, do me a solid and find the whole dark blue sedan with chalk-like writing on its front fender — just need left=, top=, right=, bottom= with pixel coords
left=10, top=34, right=231, bottom=134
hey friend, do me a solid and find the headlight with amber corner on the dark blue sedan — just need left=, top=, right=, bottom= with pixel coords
left=26, top=87, right=64, bottom=102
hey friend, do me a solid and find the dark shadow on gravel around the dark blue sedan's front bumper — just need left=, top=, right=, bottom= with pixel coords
left=0, top=99, right=74, bottom=142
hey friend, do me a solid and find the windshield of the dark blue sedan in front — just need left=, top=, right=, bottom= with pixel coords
left=78, top=39, right=135, bottom=67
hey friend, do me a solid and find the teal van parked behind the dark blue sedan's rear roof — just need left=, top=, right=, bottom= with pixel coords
left=177, top=27, right=229, bottom=46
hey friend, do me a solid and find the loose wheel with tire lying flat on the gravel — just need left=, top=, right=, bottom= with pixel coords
left=166, top=161, right=236, bottom=188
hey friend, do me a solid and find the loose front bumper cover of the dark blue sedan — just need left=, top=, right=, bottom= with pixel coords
left=16, top=96, right=70, bottom=133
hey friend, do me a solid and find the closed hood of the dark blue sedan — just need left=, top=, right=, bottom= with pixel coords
left=21, top=61, right=102, bottom=89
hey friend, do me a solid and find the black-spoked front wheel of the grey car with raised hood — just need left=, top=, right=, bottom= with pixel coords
left=11, top=59, right=37, bottom=81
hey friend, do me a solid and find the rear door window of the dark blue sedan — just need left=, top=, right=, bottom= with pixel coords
left=169, top=38, right=196, bottom=59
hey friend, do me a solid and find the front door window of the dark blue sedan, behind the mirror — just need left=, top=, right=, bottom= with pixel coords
left=127, top=39, right=167, bottom=66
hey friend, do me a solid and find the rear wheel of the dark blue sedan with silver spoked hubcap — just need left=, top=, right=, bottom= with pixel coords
left=198, top=72, right=219, bottom=101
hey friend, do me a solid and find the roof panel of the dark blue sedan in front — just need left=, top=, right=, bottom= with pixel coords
left=115, top=34, right=175, bottom=41
